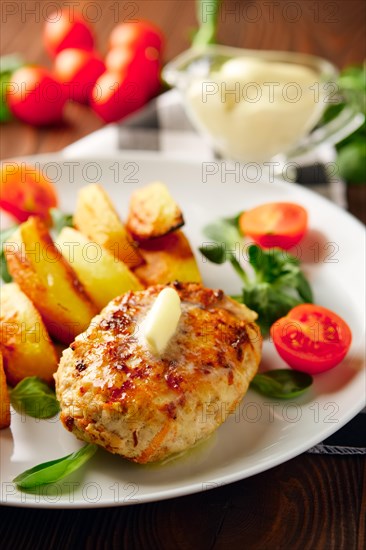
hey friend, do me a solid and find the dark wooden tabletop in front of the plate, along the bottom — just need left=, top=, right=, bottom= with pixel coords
left=0, top=455, right=365, bottom=550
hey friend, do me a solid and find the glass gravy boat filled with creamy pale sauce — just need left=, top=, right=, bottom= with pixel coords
left=163, top=45, right=364, bottom=163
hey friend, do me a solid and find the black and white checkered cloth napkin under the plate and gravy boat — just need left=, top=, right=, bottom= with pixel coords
left=63, top=90, right=366, bottom=455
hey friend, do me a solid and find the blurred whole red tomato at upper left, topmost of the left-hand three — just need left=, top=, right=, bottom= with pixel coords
left=43, top=10, right=94, bottom=57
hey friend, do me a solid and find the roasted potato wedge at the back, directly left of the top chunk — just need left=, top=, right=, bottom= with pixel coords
left=73, top=184, right=143, bottom=268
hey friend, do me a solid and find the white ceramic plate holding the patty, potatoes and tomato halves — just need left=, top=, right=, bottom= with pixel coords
left=1, top=154, right=365, bottom=508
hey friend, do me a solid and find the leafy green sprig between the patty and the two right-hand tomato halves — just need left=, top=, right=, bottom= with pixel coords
left=200, top=216, right=313, bottom=334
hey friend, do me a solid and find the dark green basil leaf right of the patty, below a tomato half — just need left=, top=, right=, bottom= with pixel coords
left=250, top=369, right=313, bottom=399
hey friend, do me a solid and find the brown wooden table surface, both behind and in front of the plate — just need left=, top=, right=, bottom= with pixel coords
left=0, top=0, right=366, bottom=550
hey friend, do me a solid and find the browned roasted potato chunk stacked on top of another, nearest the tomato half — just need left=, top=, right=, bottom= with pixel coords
left=127, top=182, right=184, bottom=241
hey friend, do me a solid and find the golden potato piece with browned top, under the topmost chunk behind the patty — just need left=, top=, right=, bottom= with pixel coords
left=134, top=231, right=201, bottom=286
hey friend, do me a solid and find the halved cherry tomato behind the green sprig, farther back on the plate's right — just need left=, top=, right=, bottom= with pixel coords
left=239, top=202, right=308, bottom=250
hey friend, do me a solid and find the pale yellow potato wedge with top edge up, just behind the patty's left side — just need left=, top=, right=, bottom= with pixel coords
left=56, top=227, right=143, bottom=310
